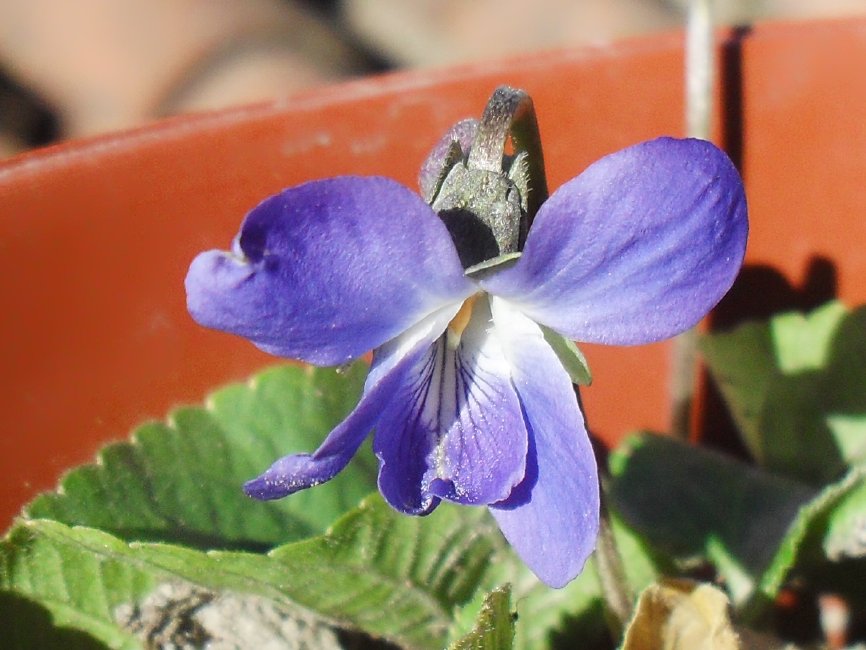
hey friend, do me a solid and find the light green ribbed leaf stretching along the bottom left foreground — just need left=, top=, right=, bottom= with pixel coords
left=0, top=497, right=504, bottom=648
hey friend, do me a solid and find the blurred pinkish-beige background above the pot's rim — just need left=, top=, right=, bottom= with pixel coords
left=0, top=0, right=866, bottom=158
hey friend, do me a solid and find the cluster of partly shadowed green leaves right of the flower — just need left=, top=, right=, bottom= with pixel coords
left=611, top=302, right=866, bottom=619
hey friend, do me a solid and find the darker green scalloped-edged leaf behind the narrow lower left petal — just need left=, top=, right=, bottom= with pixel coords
left=26, top=363, right=376, bottom=550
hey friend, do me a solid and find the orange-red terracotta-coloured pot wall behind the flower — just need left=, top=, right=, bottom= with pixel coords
left=0, top=20, right=866, bottom=526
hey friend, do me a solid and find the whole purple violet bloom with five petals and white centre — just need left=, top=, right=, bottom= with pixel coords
left=186, top=138, right=748, bottom=587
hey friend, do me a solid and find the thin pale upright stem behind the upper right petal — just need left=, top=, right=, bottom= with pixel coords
left=670, top=0, right=715, bottom=439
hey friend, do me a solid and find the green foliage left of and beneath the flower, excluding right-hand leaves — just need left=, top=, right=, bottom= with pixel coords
left=0, top=365, right=654, bottom=650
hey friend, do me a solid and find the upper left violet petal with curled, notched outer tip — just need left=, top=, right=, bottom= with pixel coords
left=186, top=176, right=474, bottom=365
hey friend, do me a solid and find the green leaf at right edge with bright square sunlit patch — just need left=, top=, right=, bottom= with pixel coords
left=701, top=302, right=866, bottom=485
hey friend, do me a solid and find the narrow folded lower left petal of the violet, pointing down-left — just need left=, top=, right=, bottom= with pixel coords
left=244, top=304, right=460, bottom=499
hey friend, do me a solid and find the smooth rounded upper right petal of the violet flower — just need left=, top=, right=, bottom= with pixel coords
left=481, top=138, right=748, bottom=345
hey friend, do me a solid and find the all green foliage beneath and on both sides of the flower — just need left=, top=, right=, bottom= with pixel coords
left=16, top=304, right=866, bottom=650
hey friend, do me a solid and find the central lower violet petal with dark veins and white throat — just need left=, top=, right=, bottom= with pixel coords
left=373, top=298, right=528, bottom=514
